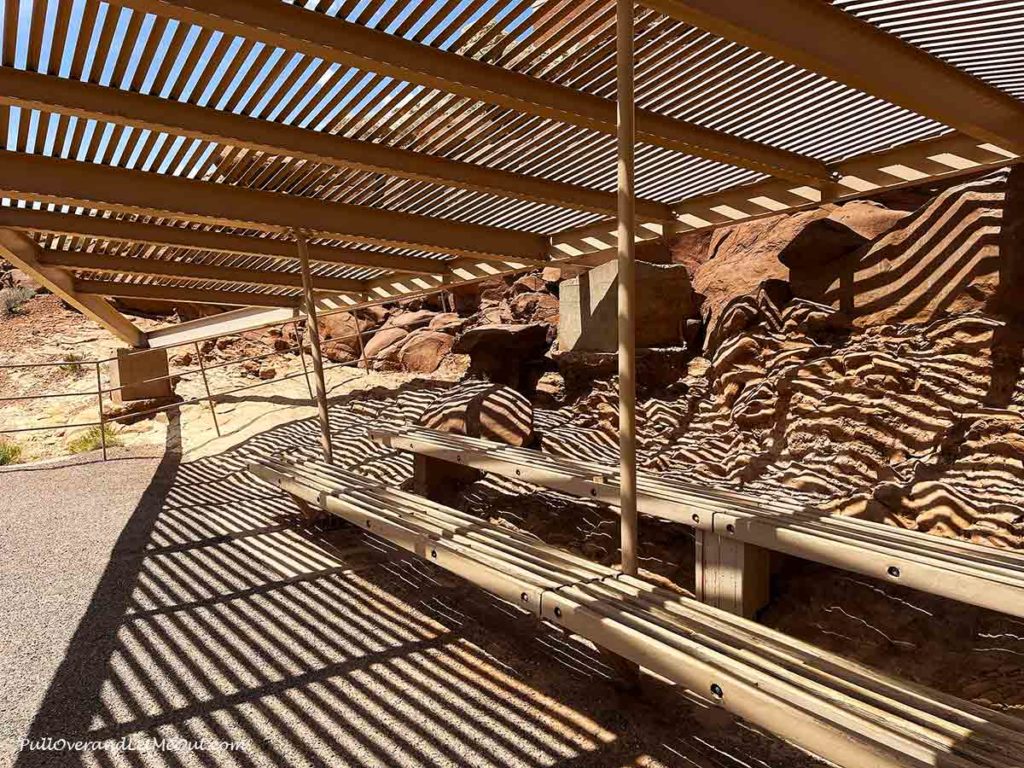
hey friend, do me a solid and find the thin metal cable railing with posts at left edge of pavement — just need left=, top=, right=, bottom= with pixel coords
left=0, top=319, right=378, bottom=461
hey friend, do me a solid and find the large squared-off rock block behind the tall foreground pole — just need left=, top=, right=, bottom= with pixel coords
left=558, top=261, right=697, bottom=352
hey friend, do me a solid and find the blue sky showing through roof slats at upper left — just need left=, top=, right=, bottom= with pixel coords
left=0, top=0, right=531, bottom=174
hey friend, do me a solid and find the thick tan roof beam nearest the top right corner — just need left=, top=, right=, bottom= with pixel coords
left=641, top=0, right=1024, bottom=154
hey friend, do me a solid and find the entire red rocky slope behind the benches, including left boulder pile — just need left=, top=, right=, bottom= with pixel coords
left=313, top=166, right=1024, bottom=548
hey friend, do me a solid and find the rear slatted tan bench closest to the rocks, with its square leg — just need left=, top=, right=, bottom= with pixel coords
left=371, top=427, right=1024, bottom=617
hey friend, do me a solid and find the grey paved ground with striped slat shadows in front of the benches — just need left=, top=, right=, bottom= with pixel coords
left=0, top=403, right=816, bottom=768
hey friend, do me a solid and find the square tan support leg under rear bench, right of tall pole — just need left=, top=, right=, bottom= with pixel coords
left=695, top=530, right=771, bottom=618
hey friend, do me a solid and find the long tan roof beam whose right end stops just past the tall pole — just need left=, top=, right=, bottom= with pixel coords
left=0, top=68, right=672, bottom=220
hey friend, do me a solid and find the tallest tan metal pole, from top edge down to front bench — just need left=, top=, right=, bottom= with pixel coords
left=615, top=0, right=637, bottom=574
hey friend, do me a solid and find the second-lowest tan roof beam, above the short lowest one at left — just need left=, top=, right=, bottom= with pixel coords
left=39, top=251, right=367, bottom=295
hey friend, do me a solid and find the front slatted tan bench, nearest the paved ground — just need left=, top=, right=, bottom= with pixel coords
left=250, top=459, right=1024, bottom=768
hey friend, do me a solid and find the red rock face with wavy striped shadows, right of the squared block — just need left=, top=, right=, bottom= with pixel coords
left=546, top=171, right=1024, bottom=548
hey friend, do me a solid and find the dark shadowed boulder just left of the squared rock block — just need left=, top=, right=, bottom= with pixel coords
left=453, top=323, right=549, bottom=394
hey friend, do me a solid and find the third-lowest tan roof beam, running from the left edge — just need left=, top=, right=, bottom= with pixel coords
left=0, top=208, right=449, bottom=274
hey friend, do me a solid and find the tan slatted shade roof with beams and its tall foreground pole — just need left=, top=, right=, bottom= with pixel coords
left=0, top=0, right=1024, bottom=552
